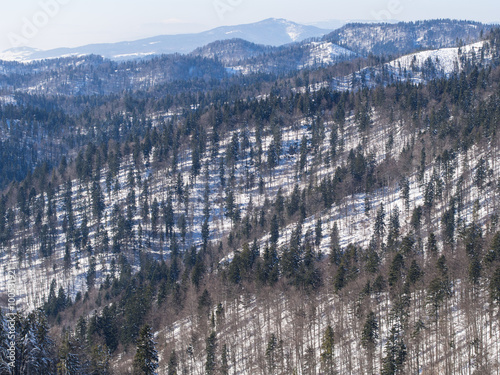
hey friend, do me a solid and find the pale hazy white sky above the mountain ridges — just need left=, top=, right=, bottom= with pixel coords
left=0, top=0, right=500, bottom=51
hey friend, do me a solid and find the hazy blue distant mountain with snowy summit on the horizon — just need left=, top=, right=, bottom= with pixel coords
left=0, top=18, right=330, bottom=62
